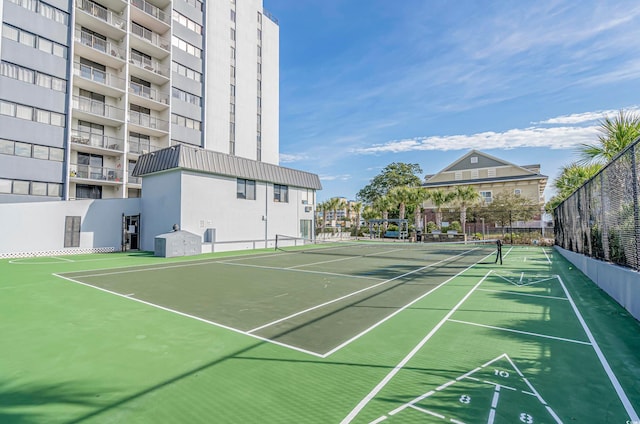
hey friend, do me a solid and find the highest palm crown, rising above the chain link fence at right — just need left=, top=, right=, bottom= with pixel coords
left=578, top=110, right=640, bottom=165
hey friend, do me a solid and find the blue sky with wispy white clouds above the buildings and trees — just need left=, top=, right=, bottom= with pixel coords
left=264, top=0, right=640, bottom=201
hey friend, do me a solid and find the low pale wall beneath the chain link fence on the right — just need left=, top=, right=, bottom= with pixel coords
left=555, top=246, right=640, bottom=320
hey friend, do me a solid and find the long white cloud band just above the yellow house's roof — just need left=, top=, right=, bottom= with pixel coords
left=352, top=126, right=598, bottom=154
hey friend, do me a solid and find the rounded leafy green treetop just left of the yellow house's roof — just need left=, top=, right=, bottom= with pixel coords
left=356, top=162, right=422, bottom=204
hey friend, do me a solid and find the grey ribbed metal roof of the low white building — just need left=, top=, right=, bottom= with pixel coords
left=133, top=144, right=322, bottom=190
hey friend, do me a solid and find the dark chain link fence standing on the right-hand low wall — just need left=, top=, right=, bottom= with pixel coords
left=553, top=138, right=640, bottom=270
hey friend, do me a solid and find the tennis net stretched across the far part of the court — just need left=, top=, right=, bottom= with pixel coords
left=275, top=235, right=496, bottom=261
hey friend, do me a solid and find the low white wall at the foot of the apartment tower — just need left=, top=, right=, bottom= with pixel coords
left=0, top=199, right=144, bottom=257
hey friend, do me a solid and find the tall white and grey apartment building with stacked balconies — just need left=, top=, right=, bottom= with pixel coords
left=0, top=0, right=279, bottom=203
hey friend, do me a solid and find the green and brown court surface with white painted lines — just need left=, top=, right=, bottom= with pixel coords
left=0, top=244, right=640, bottom=423
